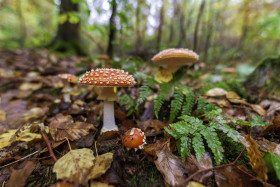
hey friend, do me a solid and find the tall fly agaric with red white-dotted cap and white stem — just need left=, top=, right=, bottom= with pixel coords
left=80, top=68, right=136, bottom=133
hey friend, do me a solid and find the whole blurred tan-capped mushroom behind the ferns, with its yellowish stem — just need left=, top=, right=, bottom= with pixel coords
left=152, top=48, right=199, bottom=82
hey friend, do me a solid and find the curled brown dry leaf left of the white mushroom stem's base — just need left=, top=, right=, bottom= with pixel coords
left=49, top=114, right=95, bottom=141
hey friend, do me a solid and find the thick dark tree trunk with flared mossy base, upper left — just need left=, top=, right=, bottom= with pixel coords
left=48, top=0, right=86, bottom=55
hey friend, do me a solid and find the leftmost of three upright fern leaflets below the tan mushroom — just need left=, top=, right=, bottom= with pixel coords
left=154, top=83, right=172, bottom=118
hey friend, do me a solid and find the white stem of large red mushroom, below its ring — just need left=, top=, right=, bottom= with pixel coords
left=101, top=101, right=118, bottom=133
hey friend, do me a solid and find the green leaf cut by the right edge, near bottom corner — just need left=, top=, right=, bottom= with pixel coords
left=263, top=152, right=280, bottom=180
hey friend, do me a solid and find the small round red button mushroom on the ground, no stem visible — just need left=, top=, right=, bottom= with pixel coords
left=122, top=128, right=146, bottom=150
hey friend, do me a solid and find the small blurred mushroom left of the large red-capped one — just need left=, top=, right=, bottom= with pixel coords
left=57, top=73, right=77, bottom=103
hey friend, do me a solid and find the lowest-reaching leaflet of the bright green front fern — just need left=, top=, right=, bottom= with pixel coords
left=201, top=127, right=224, bottom=164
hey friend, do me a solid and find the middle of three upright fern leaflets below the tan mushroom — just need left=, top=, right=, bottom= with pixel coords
left=169, top=87, right=184, bottom=123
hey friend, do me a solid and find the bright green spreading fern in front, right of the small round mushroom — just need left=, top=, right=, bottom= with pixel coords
left=165, top=98, right=266, bottom=164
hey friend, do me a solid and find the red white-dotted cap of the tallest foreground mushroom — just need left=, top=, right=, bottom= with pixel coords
left=80, top=68, right=136, bottom=87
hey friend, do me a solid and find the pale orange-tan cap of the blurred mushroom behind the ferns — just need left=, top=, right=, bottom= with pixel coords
left=152, top=48, right=199, bottom=66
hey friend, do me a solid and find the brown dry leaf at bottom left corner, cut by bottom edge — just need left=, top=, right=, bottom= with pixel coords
left=7, top=161, right=36, bottom=187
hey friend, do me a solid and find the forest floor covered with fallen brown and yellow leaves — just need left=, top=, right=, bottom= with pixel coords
left=0, top=50, right=280, bottom=187
